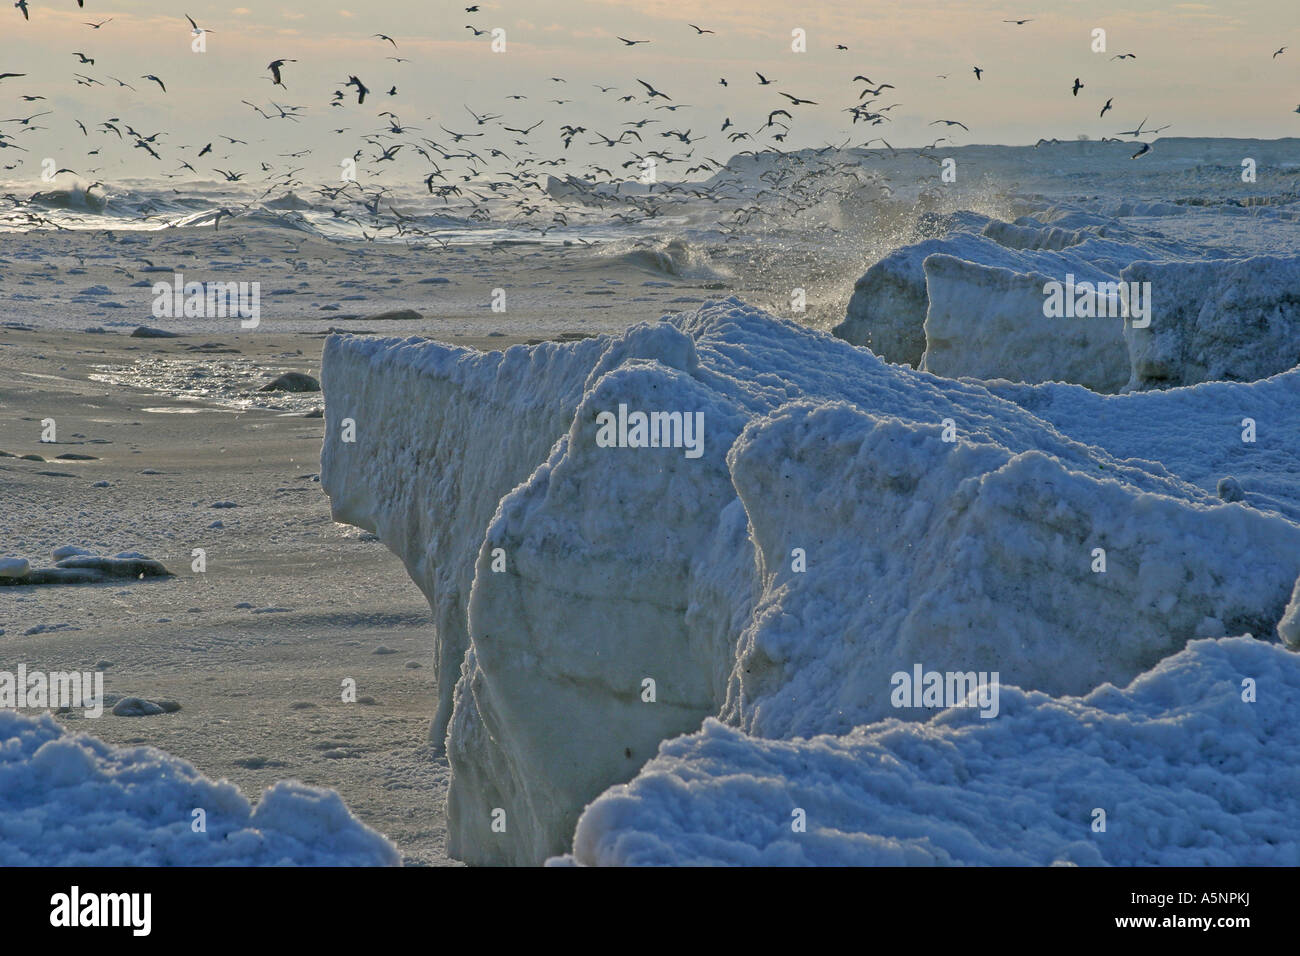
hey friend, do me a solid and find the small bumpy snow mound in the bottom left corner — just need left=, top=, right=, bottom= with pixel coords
left=0, top=710, right=400, bottom=866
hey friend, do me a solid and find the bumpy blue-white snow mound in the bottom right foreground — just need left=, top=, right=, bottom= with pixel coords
left=555, top=637, right=1300, bottom=866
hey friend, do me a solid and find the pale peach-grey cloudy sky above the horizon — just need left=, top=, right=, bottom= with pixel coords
left=0, top=0, right=1300, bottom=183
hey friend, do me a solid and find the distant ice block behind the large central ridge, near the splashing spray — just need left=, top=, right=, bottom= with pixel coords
left=835, top=206, right=1300, bottom=393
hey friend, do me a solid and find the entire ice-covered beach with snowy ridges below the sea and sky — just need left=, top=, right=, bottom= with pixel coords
left=0, top=140, right=1300, bottom=865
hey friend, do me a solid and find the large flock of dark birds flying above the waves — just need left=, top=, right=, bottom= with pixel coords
left=0, top=6, right=1300, bottom=238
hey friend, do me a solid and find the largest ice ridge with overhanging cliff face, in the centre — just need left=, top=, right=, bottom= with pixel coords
left=322, top=300, right=1300, bottom=864
